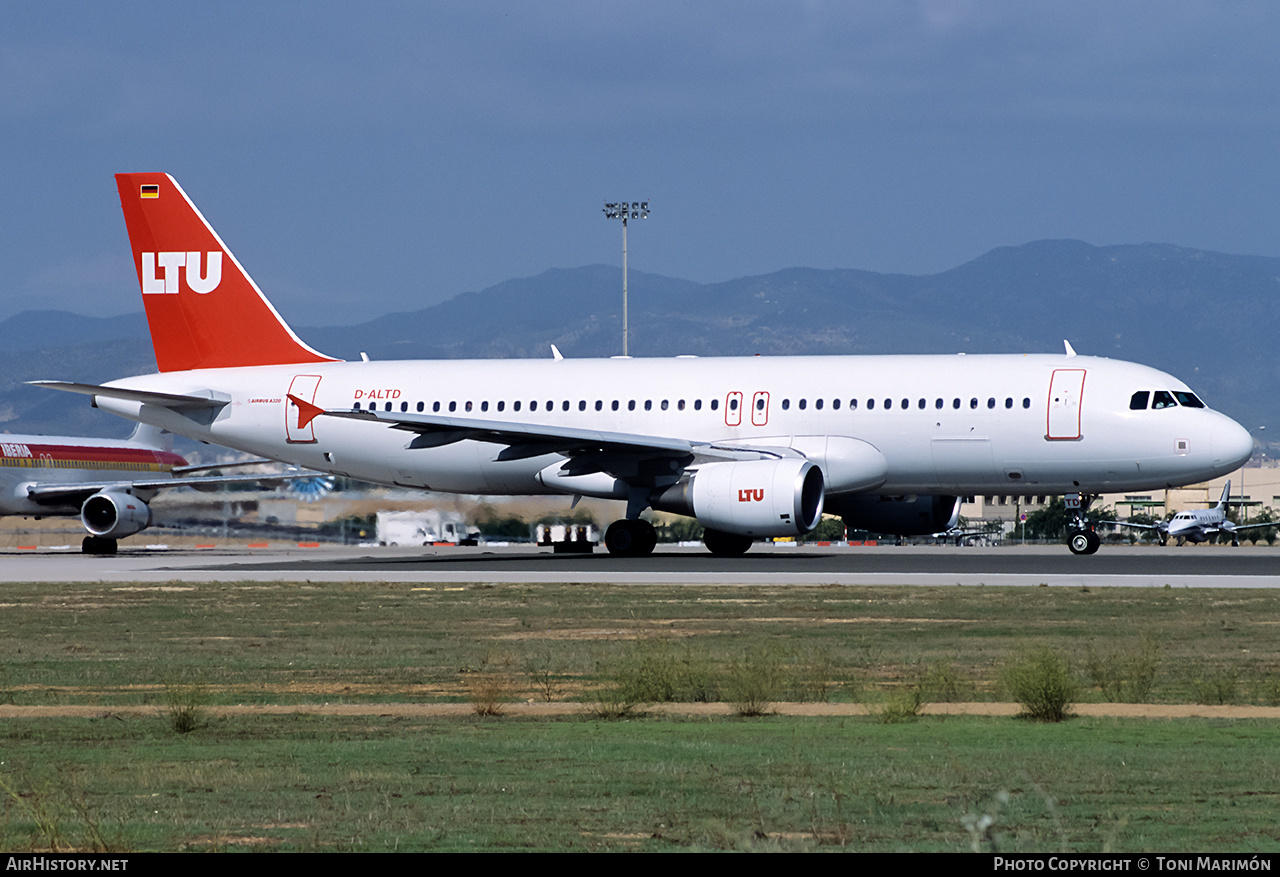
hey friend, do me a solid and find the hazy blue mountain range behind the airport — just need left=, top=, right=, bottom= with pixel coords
left=0, top=241, right=1280, bottom=435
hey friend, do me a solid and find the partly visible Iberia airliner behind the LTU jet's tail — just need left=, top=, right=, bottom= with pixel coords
left=0, top=424, right=288, bottom=554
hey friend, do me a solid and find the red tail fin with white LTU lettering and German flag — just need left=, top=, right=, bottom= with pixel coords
left=115, top=174, right=335, bottom=371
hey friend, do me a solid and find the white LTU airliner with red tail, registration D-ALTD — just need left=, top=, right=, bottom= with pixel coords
left=35, top=173, right=1253, bottom=556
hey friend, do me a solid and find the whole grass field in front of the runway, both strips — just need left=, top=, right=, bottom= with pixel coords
left=0, top=583, right=1280, bottom=851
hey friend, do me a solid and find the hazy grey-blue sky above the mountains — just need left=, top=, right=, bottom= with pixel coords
left=0, top=0, right=1280, bottom=322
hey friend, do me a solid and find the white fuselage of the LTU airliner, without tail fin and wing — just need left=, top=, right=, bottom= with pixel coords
left=97, top=355, right=1252, bottom=494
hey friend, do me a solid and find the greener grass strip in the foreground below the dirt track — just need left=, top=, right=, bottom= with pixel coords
left=0, top=716, right=1280, bottom=853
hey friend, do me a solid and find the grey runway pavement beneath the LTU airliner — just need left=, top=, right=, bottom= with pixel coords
left=0, top=545, right=1280, bottom=588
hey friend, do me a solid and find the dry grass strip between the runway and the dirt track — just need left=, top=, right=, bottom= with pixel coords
left=0, top=583, right=1280, bottom=705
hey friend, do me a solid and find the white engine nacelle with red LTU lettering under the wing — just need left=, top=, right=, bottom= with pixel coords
left=650, top=457, right=824, bottom=536
